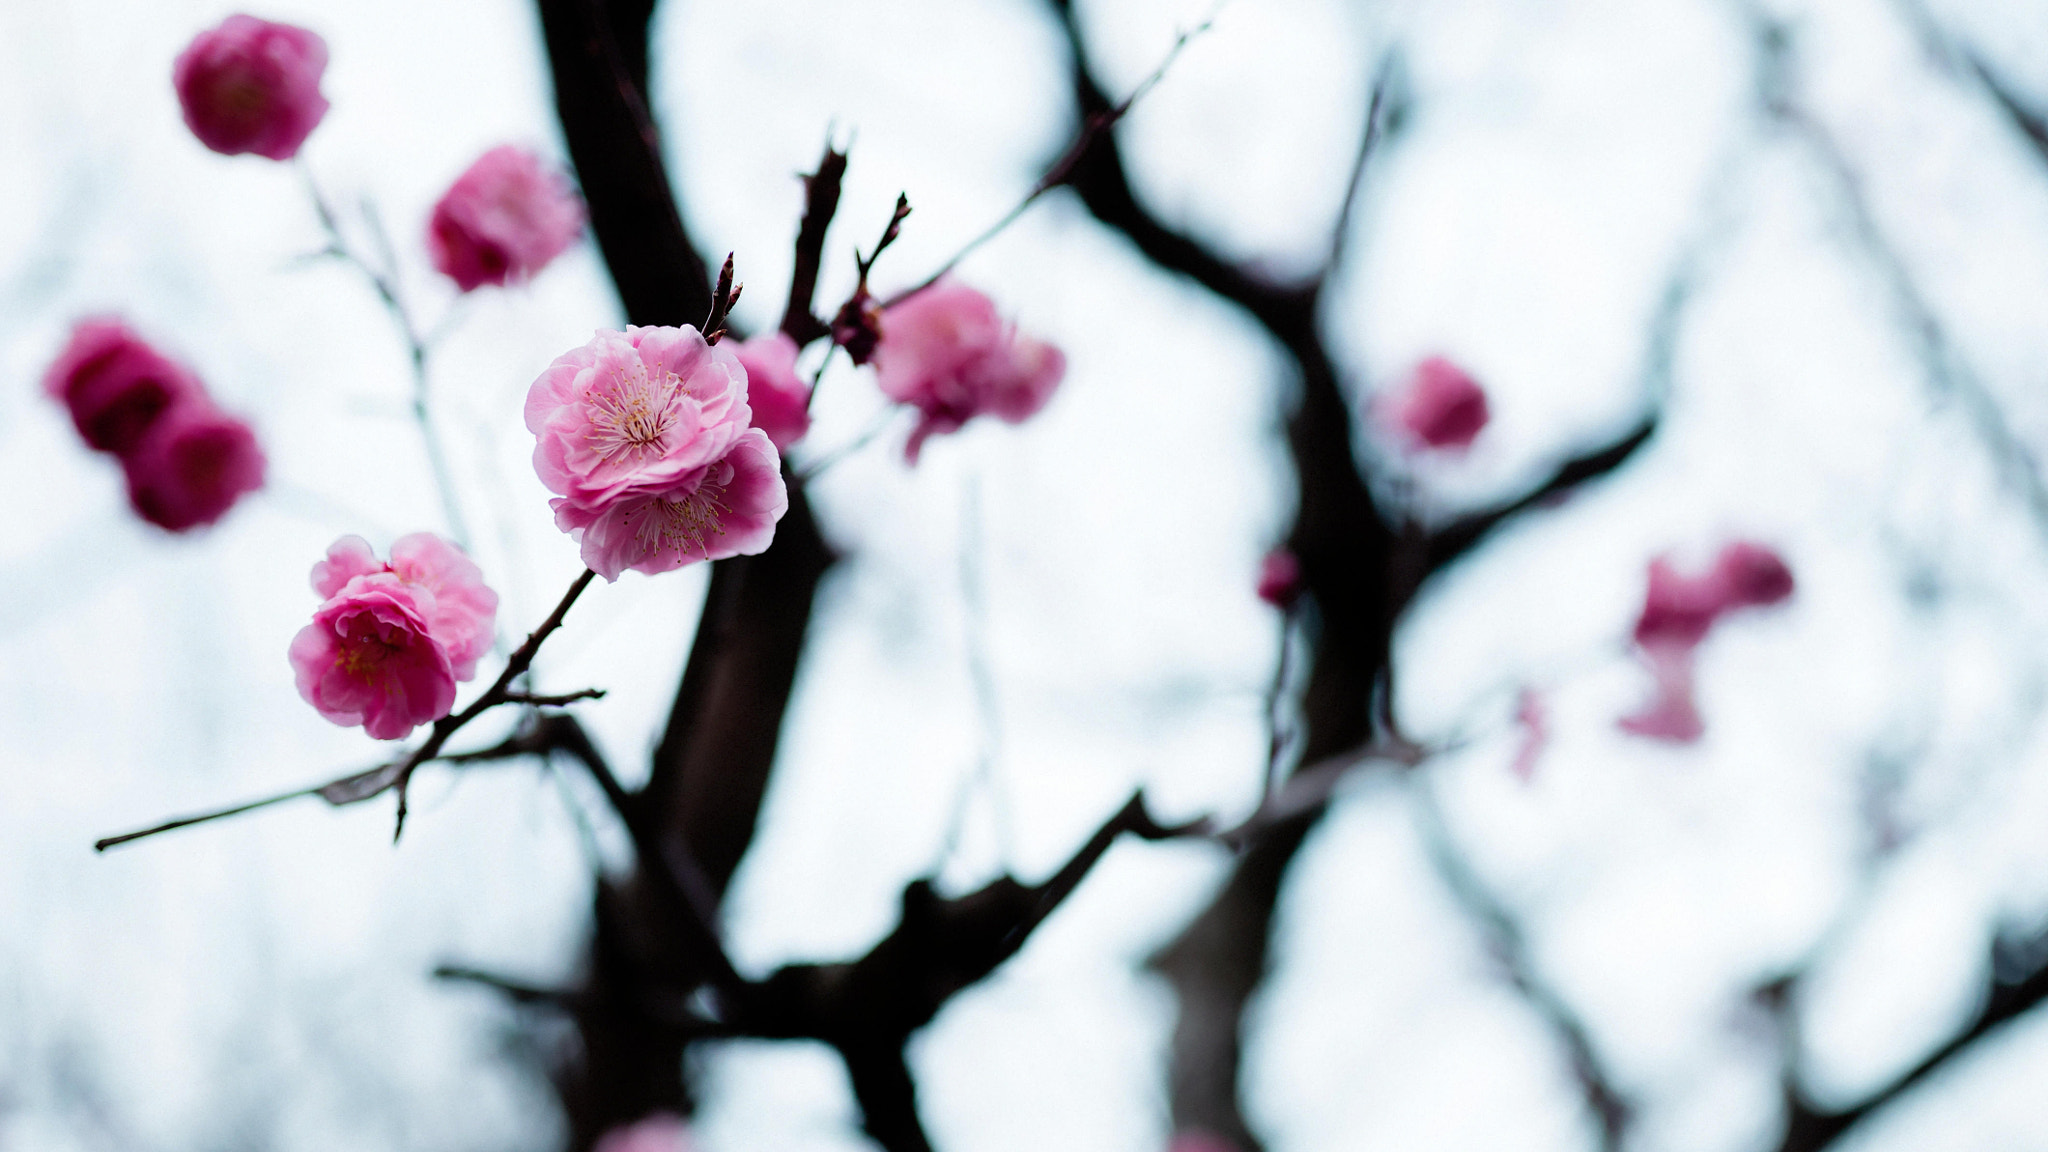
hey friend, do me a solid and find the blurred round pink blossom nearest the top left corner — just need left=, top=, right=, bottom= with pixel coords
left=170, top=16, right=328, bottom=160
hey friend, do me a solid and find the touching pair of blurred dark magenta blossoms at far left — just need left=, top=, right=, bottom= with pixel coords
left=43, top=318, right=264, bottom=533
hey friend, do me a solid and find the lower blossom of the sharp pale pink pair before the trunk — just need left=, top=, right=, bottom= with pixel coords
left=549, top=428, right=788, bottom=580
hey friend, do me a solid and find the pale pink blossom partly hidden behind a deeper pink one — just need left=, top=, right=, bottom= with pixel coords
left=313, top=533, right=498, bottom=681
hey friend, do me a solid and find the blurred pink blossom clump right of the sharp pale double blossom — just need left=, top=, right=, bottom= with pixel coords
left=872, top=281, right=1067, bottom=463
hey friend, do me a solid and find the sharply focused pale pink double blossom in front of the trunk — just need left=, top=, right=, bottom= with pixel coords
left=526, top=326, right=788, bottom=580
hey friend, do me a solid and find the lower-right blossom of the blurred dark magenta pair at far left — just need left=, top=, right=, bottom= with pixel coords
left=121, top=398, right=264, bottom=533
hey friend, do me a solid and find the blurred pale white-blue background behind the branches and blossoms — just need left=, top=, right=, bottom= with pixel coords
left=0, top=0, right=2048, bottom=1152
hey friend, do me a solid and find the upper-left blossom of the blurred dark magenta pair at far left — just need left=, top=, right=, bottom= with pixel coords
left=43, top=318, right=205, bottom=455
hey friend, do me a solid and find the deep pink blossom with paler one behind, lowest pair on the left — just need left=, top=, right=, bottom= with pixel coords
left=291, top=533, right=498, bottom=740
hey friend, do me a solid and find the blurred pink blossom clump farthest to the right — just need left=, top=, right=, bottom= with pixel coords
left=1620, top=541, right=1792, bottom=744
